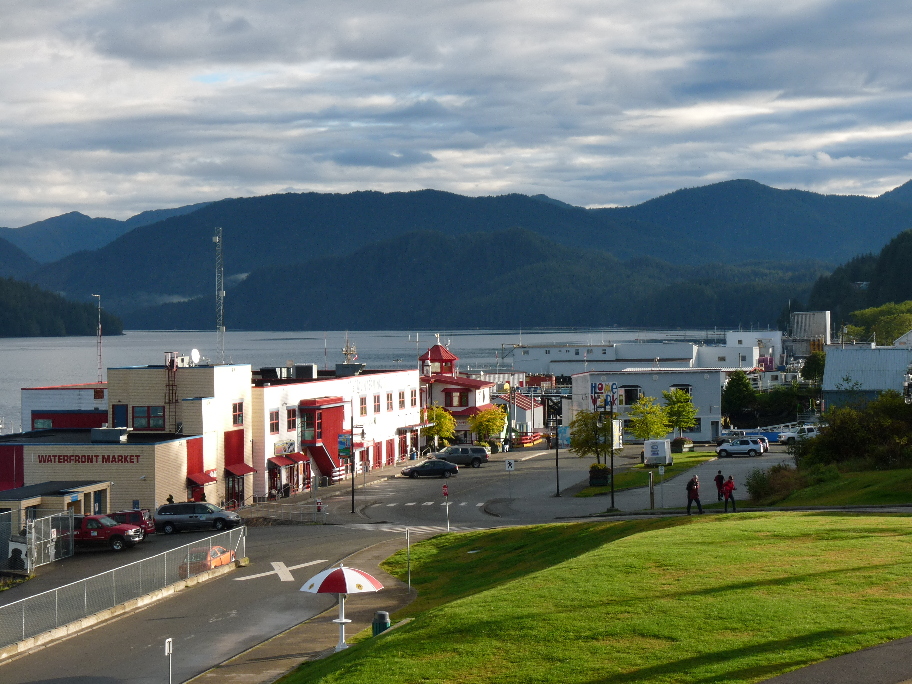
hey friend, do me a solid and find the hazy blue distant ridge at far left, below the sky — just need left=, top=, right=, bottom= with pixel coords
left=0, top=202, right=208, bottom=263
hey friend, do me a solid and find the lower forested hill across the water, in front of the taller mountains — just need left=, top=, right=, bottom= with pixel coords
left=124, top=228, right=820, bottom=330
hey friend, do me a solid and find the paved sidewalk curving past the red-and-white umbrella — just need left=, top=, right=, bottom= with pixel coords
left=187, top=539, right=415, bottom=684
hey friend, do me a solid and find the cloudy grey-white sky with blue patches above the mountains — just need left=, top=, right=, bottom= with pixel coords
left=0, top=0, right=912, bottom=227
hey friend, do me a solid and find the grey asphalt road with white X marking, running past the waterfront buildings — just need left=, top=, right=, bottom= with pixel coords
left=0, top=450, right=783, bottom=684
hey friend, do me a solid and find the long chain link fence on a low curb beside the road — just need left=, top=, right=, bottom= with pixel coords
left=0, top=527, right=247, bottom=648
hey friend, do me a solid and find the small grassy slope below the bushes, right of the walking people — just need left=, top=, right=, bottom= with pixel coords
left=764, top=469, right=912, bottom=506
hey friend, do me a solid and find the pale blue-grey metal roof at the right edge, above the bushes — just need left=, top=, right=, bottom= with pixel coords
left=821, top=345, right=912, bottom=392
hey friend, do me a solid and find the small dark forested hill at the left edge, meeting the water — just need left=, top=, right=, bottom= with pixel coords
left=0, top=278, right=123, bottom=337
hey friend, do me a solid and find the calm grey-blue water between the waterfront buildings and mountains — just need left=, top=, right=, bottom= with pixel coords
left=0, top=329, right=728, bottom=433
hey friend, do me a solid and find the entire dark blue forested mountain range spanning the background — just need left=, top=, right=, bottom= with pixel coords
left=0, top=180, right=912, bottom=329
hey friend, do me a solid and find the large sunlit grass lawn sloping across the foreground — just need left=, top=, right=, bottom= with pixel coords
left=281, top=512, right=912, bottom=684
